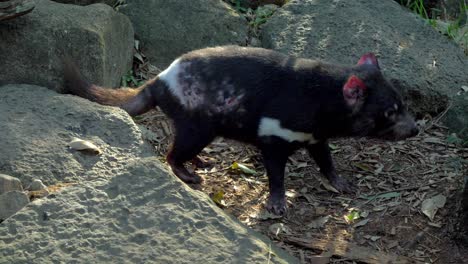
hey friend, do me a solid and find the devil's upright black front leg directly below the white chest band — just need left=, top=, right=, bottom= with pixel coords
left=260, top=140, right=292, bottom=215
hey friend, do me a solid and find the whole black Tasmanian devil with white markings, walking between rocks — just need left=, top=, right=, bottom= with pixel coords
left=65, top=46, right=418, bottom=214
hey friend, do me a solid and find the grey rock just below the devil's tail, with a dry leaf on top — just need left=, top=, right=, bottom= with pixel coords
left=0, top=85, right=153, bottom=186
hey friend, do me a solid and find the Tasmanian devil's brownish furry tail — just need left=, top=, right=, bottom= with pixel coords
left=64, top=58, right=156, bottom=116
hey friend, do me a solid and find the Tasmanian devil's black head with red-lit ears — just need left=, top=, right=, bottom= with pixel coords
left=343, top=53, right=419, bottom=140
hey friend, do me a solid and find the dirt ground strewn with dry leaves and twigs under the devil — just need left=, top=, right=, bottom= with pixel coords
left=133, top=106, right=468, bottom=263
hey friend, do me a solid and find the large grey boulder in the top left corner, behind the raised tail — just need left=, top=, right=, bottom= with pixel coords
left=0, top=0, right=134, bottom=91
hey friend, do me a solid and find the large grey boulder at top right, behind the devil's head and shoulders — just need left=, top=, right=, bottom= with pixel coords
left=262, top=0, right=468, bottom=137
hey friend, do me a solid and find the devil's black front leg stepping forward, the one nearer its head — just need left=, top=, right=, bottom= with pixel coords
left=307, top=140, right=352, bottom=193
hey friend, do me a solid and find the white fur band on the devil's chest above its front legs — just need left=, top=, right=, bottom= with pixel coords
left=258, top=117, right=318, bottom=144
